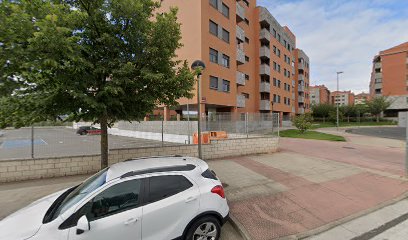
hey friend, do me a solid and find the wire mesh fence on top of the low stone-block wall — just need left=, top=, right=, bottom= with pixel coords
left=0, top=113, right=280, bottom=159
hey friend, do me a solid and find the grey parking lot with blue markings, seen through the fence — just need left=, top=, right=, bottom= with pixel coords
left=0, top=127, right=176, bottom=159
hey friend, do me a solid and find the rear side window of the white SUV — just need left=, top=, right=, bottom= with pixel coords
left=148, top=175, right=193, bottom=203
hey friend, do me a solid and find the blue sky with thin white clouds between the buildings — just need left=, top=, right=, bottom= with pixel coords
left=257, top=0, right=408, bottom=93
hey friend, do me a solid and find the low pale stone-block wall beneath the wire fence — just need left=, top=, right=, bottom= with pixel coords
left=0, top=137, right=279, bottom=183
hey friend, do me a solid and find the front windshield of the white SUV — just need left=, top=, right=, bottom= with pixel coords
left=53, top=168, right=108, bottom=219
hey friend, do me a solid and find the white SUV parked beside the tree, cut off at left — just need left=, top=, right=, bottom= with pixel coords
left=0, top=156, right=229, bottom=240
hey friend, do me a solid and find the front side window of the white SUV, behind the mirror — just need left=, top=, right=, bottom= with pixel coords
left=85, top=179, right=141, bottom=221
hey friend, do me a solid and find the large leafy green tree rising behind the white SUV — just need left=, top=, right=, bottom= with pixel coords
left=0, top=0, right=194, bottom=167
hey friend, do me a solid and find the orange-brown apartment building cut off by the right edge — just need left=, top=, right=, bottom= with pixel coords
left=370, top=42, right=408, bottom=116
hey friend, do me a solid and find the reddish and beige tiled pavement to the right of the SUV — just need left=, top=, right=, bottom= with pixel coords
left=209, top=139, right=408, bottom=240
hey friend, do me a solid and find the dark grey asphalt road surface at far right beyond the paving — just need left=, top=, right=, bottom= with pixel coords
left=346, top=127, right=406, bottom=140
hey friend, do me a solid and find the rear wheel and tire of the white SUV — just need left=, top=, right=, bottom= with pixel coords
left=184, top=216, right=221, bottom=240
